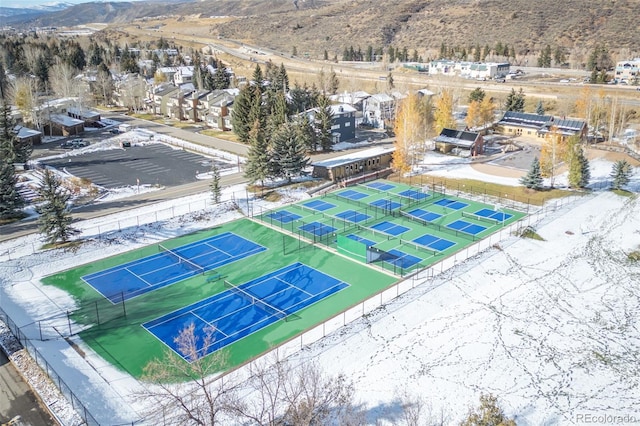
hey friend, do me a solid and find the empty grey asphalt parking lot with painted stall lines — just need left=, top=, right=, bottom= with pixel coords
left=42, top=143, right=235, bottom=189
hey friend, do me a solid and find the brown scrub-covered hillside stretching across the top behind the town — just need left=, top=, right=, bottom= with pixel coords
left=6, top=0, right=640, bottom=61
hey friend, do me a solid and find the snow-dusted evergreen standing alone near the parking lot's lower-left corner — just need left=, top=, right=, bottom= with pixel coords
left=36, top=170, right=80, bottom=244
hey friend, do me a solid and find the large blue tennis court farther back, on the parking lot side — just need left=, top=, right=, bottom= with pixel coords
left=82, top=232, right=266, bottom=303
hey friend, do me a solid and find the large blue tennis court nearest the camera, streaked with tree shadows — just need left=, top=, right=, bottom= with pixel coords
left=142, top=263, right=349, bottom=361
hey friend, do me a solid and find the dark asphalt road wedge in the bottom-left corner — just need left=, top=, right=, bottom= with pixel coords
left=0, top=350, right=58, bottom=426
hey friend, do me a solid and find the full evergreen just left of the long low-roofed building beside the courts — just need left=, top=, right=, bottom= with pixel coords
left=271, top=123, right=309, bottom=183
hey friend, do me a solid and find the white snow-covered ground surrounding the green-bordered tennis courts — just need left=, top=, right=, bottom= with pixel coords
left=0, top=150, right=640, bottom=425
